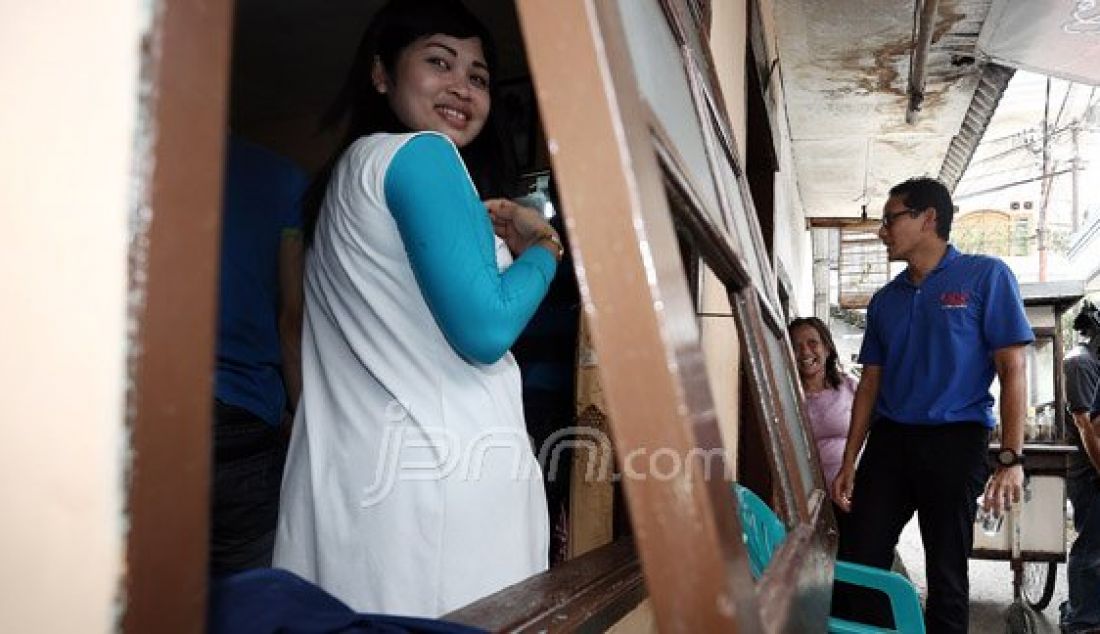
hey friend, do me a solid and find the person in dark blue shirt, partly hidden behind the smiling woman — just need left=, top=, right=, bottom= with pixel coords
left=210, top=136, right=307, bottom=576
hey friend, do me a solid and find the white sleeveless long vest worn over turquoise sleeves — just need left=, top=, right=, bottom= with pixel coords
left=274, top=134, right=549, bottom=616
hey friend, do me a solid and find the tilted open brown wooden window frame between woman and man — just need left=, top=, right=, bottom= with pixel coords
left=517, top=0, right=832, bottom=631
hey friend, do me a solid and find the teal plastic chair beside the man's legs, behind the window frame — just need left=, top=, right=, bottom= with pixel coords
left=734, top=482, right=924, bottom=634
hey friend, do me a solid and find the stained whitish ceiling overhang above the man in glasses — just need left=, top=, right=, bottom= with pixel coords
left=776, top=0, right=990, bottom=218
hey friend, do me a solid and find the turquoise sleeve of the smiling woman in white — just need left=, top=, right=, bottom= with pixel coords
left=385, top=134, right=558, bottom=363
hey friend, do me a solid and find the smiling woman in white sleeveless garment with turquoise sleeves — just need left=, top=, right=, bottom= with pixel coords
left=275, top=0, right=561, bottom=616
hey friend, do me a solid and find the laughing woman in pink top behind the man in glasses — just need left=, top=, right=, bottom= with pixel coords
left=787, top=317, right=856, bottom=491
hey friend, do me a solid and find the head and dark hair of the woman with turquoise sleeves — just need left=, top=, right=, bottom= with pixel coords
left=305, top=0, right=517, bottom=242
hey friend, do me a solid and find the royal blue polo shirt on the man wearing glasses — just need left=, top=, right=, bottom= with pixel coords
left=859, top=245, right=1035, bottom=427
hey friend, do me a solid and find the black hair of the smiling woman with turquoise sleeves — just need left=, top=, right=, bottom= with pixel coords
left=304, top=0, right=516, bottom=244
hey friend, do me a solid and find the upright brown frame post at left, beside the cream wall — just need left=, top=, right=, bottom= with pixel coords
left=122, top=0, right=233, bottom=633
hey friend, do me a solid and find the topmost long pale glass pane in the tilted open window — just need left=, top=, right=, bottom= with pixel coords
left=619, top=0, right=725, bottom=227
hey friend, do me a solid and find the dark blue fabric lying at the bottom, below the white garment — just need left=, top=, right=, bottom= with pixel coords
left=207, top=568, right=484, bottom=634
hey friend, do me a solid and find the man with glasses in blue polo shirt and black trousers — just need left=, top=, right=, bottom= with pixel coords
left=833, top=178, right=1034, bottom=632
